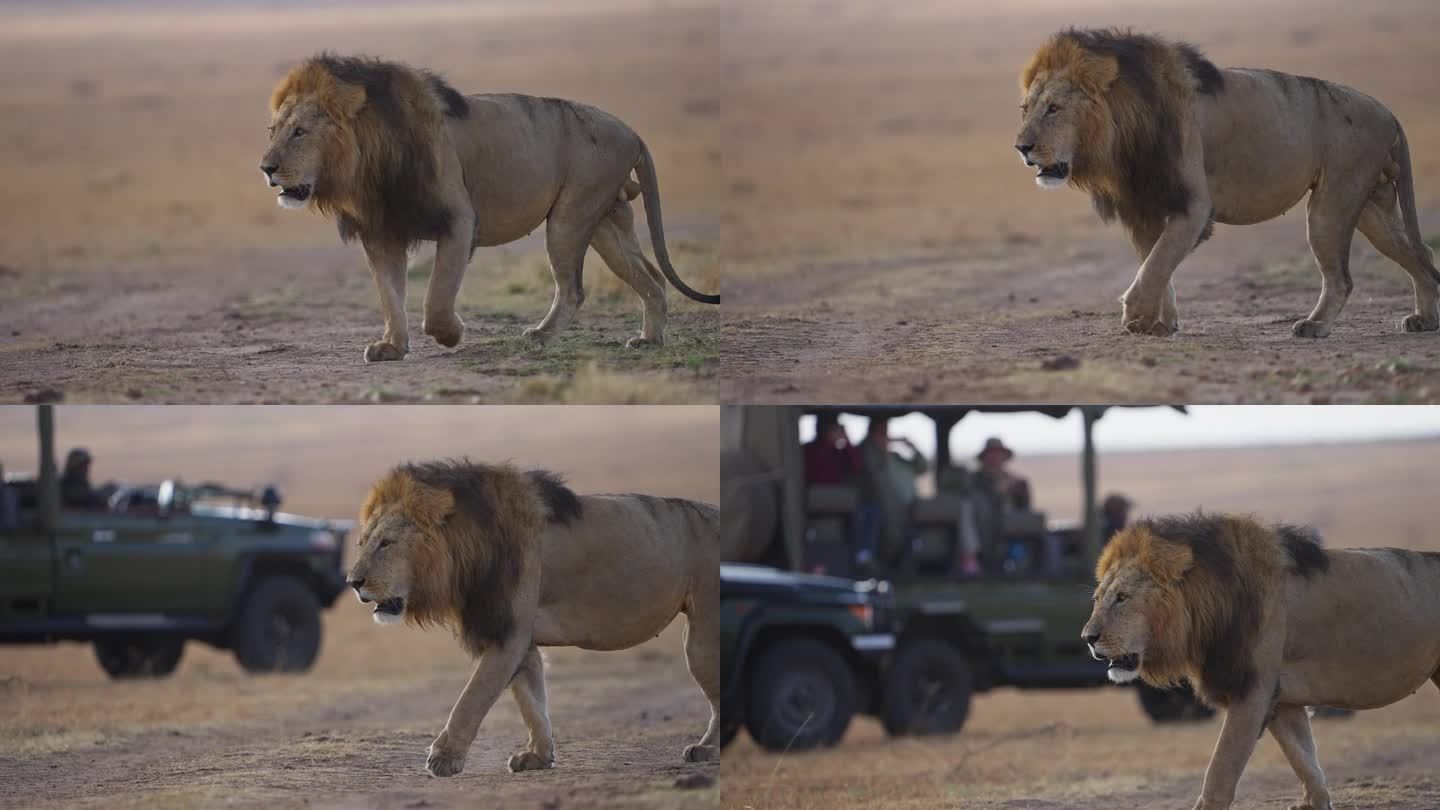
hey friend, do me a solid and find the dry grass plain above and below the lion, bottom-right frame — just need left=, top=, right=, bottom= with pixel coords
left=721, top=440, right=1440, bottom=810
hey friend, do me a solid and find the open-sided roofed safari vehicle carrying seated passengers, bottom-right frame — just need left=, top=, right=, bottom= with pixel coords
left=720, top=405, right=1210, bottom=735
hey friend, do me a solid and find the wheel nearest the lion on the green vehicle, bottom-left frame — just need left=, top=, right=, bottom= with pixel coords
left=232, top=577, right=320, bottom=672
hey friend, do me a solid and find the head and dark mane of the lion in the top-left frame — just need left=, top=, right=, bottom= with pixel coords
left=261, top=53, right=469, bottom=245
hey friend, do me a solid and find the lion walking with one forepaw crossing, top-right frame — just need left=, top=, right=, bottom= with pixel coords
left=1015, top=29, right=1440, bottom=337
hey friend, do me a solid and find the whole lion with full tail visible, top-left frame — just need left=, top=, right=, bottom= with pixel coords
left=261, top=53, right=720, bottom=362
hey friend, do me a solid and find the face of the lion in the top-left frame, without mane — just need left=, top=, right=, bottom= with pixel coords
left=261, top=95, right=348, bottom=209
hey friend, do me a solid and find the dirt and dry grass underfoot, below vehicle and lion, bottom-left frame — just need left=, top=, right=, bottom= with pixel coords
left=0, top=616, right=719, bottom=809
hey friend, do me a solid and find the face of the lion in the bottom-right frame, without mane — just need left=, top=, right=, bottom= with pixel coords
left=1080, top=562, right=1162, bottom=683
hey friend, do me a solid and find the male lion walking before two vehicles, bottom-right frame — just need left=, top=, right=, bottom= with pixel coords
left=1081, top=512, right=1440, bottom=810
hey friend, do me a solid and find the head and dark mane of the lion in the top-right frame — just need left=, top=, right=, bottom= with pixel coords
left=1015, top=29, right=1224, bottom=223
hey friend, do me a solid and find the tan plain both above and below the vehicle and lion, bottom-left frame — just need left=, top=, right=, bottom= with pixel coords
left=0, top=406, right=719, bottom=807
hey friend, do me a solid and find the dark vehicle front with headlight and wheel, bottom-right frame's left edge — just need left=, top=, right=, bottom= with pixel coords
left=720, top=565, right=896, bottom=751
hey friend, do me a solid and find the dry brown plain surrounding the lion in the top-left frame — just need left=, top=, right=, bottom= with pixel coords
left=0, top=0, right=720, bottom=402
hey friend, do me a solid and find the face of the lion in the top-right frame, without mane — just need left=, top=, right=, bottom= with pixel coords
left=1015, top=76, right=1093, bottom=189
